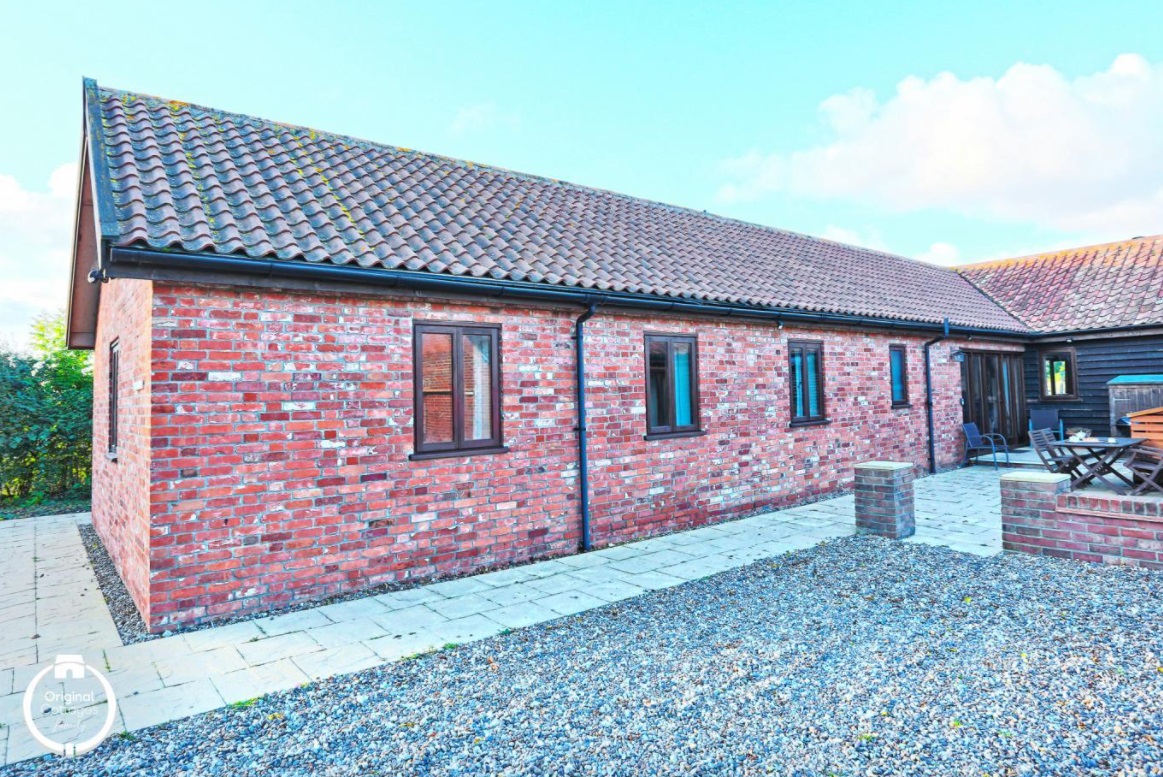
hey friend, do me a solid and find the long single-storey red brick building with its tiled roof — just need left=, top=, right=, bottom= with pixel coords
left=69, top=81, right=1029, bottom=629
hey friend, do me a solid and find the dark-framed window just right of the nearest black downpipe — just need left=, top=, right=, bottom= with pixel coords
left=647, top=335, right=699, bottom=439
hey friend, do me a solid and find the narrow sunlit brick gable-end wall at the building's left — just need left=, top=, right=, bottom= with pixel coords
left=93, top=280, right=151, bottom=622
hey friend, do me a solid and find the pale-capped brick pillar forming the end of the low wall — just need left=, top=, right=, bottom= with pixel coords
left=1001, top=470, right=1070, bottom=556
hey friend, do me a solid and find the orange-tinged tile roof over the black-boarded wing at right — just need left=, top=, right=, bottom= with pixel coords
left=957, top=235, right=1163, bottom=333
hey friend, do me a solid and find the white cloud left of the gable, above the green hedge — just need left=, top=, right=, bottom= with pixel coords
left=0, top=163, right=77, bottom=345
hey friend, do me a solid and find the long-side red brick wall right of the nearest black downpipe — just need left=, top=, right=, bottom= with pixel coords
left=586, top=314, right=982, bottom=542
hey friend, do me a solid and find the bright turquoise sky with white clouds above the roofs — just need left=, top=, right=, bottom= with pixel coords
left=0, top=0, right=1163, bottom=342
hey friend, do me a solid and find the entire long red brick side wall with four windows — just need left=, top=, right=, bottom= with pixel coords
left=90, top=280, right=1018, bottom=628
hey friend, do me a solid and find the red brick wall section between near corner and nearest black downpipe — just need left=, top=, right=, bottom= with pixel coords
left=151, top=284, right=578, bottom=626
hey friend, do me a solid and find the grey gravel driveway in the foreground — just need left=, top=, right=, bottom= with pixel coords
left=12, top=537, right=1163, bottom=777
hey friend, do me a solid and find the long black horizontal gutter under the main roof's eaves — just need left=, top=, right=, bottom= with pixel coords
left=104, top=247, right=1029, bottom=338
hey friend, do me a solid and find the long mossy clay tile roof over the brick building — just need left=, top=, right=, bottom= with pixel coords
left=90, top=83, right=1026, bottom=332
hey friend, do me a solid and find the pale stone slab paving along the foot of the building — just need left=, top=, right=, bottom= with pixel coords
left=0, top=468, right=1001, bottom=765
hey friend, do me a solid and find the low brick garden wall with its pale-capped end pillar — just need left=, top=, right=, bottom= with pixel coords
left=1001, top=471, right=1163, bottom=569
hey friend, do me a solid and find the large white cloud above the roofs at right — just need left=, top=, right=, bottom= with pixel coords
left=719, top=54, right=1163, bottom=236
